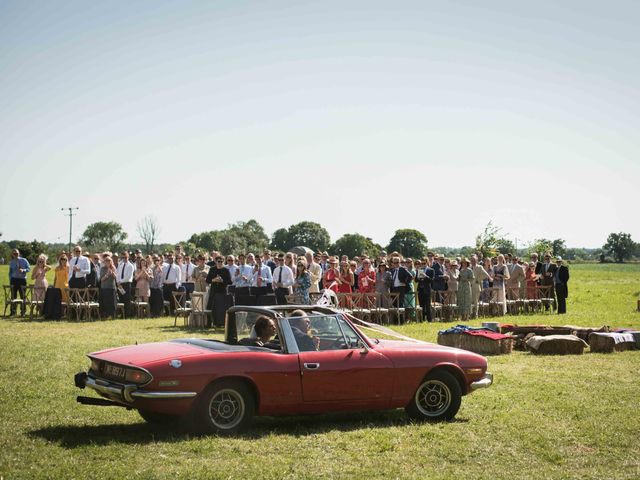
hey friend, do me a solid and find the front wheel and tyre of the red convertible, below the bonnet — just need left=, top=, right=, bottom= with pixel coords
left=405, top=370, right=462, bottom=422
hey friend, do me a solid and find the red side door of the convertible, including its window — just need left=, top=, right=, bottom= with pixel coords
left=298, top=315, right=393, bottom=408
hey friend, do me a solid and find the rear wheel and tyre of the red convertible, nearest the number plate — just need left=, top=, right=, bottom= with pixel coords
left=194, top=380, right=256, bottom=435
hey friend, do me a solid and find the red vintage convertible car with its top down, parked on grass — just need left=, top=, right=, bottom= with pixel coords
left=75, top=305, right=493, bottom=435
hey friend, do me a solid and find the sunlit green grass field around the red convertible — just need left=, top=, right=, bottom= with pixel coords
left=0, top=265, right=640, bottom=479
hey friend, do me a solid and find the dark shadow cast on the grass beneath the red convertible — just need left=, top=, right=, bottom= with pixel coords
left=29, top=410, right=468, bottom=449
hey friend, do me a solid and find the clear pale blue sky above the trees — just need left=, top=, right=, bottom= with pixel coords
left=0, top=0, right=640, bottom=247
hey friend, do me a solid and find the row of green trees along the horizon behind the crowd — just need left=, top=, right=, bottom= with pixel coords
left=0, top=220, right=640, bottom=263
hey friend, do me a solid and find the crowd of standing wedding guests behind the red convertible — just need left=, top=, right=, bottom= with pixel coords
left=9, top=245, right=569, bottom=324
